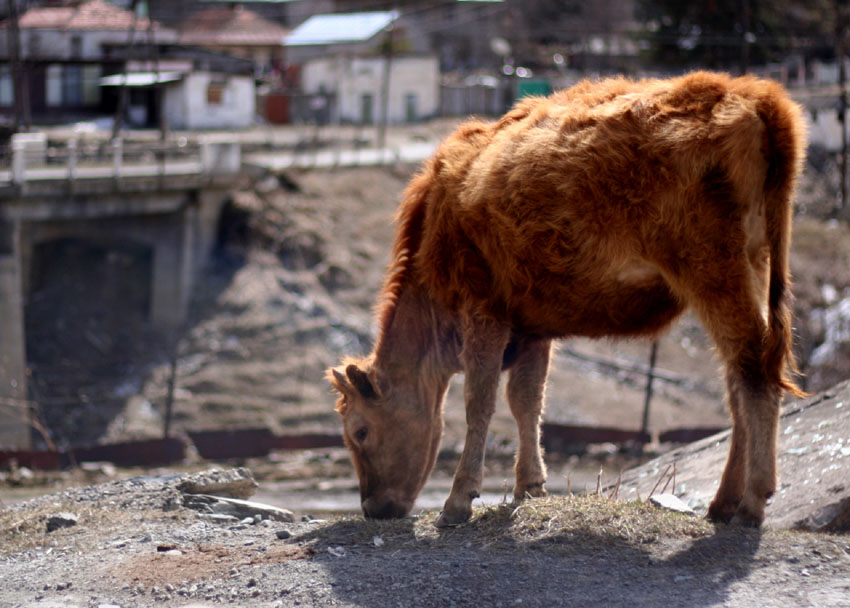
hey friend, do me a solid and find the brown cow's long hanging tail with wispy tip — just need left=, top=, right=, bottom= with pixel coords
left=759, top=81, right=806, bottom=397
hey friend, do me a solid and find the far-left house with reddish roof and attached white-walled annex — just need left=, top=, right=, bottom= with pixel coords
left=0, top=0, right=256, bottom=129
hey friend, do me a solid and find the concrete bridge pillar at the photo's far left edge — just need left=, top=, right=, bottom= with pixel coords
left=0, top=220, right=31, bottom=449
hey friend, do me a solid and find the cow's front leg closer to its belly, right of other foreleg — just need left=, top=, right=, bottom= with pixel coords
left=507, top=339, right=552, bottom=500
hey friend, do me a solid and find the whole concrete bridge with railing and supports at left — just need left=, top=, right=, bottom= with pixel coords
left=0, top=134, right=243, bottom=449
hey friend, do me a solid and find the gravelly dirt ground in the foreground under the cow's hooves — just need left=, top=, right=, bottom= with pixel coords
left=0, top=475, right=850, bottom=608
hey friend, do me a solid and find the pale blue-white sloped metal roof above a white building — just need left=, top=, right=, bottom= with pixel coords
left=285, top=11, right=398, bottom=46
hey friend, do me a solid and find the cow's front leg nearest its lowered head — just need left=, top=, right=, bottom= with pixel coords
left=435, top=321, right=510, bottom=528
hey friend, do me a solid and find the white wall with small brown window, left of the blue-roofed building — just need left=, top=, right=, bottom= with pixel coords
left=163, top=72, right=256, bottom=129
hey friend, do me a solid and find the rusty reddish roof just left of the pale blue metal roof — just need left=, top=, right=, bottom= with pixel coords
left=178, top=6, right=289, bottom=46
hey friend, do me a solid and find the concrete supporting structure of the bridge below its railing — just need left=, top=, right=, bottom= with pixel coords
left=0, top=184, right=228, bottom=449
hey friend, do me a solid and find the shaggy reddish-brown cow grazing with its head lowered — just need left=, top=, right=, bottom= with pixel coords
left=328, top=72, right=805, bottom=526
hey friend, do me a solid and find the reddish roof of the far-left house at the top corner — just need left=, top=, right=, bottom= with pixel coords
left=9, top=0, right=163, bottom=30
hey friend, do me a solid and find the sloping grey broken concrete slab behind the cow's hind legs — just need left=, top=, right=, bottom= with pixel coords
left=620, top=382, right=850, bottom=532
